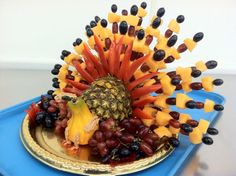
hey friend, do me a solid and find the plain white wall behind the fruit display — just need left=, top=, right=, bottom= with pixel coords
left=0, top=0, right=236, bottom=74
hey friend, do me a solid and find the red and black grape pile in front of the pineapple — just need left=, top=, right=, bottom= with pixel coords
left=89, top=118, right=172, bottom=164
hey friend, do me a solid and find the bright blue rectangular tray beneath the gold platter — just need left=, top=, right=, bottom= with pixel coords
left=0, top=91, right=225, bottom=176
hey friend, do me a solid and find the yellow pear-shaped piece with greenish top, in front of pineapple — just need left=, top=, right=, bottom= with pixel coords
left=65, top=98, right=99, bottom=146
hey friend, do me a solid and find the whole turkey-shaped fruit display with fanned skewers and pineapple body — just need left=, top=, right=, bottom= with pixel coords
left=27, top=2, right=224, bottom=164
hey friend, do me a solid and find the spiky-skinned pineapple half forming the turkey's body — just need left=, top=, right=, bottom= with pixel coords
left=81, top=76, right=132, bottom=120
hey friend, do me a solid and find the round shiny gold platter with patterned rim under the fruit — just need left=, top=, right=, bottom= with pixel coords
left=20, top=116, right=174, bottom=175
